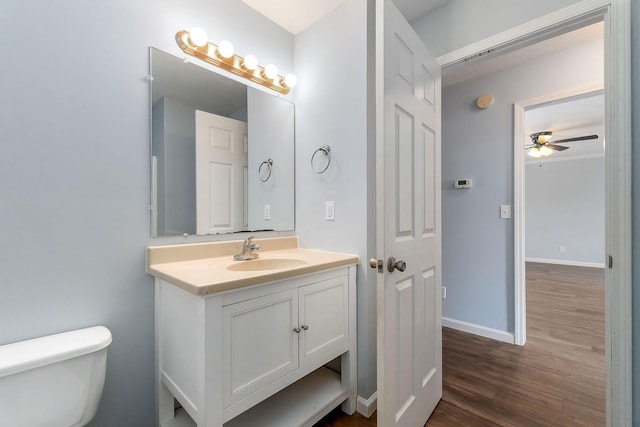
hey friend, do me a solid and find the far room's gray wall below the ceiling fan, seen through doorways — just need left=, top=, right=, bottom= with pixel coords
left=525, top=157, right=605, bottom=267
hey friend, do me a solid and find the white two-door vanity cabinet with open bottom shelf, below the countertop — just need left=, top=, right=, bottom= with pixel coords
left=156, top=265, right=356, bottom=427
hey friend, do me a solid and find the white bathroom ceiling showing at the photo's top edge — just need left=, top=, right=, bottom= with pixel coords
left=242, top=0, right=449, bottom=34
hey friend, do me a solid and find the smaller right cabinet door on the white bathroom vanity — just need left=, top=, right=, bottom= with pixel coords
left=300, top=276, right=349, bottom=364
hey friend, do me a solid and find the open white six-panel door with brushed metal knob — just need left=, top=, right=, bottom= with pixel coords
left=377, top=0, right=442, bottom=427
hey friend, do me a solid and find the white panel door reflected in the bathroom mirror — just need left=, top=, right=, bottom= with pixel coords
left=196, top=111, right=248, bottom=234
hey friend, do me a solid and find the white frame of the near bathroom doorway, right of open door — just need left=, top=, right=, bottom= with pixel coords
left=438, top=0, right=632, bottom=426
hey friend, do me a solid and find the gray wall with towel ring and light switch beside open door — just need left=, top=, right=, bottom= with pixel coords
left=295, top=0, right=376, bottom=398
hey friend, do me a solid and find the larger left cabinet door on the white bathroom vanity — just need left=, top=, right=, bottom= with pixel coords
left=222, top=289, right=298, bottom=407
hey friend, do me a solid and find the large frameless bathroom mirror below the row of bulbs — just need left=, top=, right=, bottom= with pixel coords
left=150, top=48, right=295, bottom=237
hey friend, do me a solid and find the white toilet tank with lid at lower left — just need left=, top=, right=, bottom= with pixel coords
left=0, top=326, right=111, bottom=427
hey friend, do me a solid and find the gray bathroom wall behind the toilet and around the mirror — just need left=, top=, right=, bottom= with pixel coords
left=0, top=0, right=293, bottom=427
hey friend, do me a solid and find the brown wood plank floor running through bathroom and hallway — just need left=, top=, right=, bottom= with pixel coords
left=316, top=263, right=606, bottom=427
